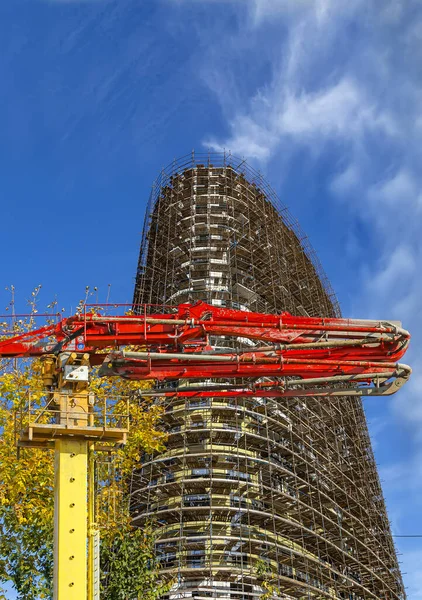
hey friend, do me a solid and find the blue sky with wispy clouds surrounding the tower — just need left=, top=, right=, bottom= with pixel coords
left=0, top=0, right=422, bottom=600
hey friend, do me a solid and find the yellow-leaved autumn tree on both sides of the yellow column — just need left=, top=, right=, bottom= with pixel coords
left=0, top=298, right=171, bottom=600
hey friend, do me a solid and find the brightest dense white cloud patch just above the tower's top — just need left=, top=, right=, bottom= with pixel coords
left=205, top=75, right=388, bottom=162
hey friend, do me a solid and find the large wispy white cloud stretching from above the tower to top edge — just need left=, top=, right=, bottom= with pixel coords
left=205, top=0, right=400, bottom=163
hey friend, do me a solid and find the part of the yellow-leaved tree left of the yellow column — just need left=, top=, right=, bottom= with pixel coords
left=0, top=364, right=54, bottom=600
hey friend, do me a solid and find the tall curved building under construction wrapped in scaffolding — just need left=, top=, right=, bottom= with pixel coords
left=131, top=154, right=405, bottom=600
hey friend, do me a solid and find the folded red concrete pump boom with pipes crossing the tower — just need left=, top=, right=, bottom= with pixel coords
left=0, top=302, right=411, bottom=395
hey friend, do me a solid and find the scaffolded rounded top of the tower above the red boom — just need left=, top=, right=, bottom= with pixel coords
left=134, top=154, right=340, bottom=316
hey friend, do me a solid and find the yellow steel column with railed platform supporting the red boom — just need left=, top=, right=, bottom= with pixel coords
left=19, top=353, right=129, bottom=600
